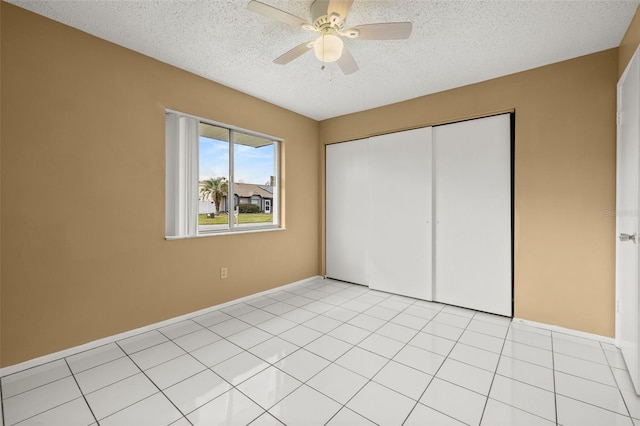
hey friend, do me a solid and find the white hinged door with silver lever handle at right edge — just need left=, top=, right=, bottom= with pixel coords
left=616, top=47, right=640, bottom=393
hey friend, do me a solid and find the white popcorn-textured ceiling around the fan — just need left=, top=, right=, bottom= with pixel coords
left=8, top=0, right=640, bottom=120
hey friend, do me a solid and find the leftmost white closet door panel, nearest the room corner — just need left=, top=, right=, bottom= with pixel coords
left=326, top=139, right=370, bottom=285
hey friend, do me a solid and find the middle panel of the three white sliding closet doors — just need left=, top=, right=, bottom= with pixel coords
left=369, top=127, right=432, bottom=300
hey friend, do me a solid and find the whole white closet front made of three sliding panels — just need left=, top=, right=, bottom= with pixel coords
left=326, top=114, right=512, bottom=316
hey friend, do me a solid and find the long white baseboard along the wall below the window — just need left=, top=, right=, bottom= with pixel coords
left=0, top=275, right=323, bottom=377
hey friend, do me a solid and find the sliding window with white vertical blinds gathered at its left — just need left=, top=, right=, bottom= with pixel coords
left=166, top=111, right=282, bottom=239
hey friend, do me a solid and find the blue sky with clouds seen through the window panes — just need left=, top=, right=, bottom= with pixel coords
left=199, top=136, right=274, bottom=185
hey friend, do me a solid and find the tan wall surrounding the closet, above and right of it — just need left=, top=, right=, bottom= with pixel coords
left=320, top=49, right=618, bottom=336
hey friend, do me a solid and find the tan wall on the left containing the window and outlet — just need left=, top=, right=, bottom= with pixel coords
left=1, top=3, right=322, bottom=366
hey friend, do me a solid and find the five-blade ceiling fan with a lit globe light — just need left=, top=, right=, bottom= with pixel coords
left=247, top=0, right=413, bottom=74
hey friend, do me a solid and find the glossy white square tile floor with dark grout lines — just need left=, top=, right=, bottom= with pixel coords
left=0, top=279, right=640, bottom=426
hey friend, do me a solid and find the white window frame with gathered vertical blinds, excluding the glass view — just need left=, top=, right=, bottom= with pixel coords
left=165, top=109, right=285, bottom=240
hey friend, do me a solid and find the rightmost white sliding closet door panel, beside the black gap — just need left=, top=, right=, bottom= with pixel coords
left=433, top=114, right=512, bottom=316
